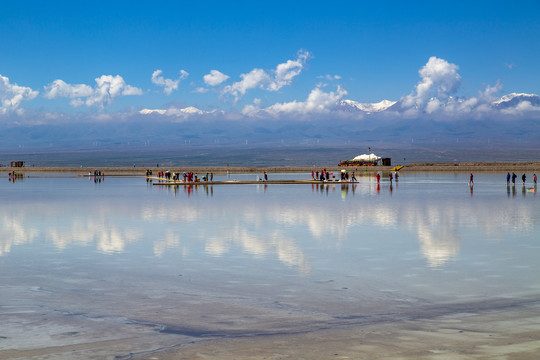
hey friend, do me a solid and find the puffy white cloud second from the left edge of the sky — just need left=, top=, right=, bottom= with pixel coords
left=43, top=75, right=143, bottom=108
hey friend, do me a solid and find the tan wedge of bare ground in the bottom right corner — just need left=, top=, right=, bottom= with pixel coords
left=144, top=305, right=540, bottom=360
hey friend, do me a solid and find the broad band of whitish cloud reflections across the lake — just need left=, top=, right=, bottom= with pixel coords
left=0, top=175, right=538, bottom=274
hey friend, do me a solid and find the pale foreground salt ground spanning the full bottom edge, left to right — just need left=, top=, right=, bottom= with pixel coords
left=0, top=301, right=540, bottom=360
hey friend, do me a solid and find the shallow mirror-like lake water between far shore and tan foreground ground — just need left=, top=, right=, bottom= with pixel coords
left=0, top=173, right=540, bottom=358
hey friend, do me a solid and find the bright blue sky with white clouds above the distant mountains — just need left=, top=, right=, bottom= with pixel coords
left=0, top=1, right=540, bottom=122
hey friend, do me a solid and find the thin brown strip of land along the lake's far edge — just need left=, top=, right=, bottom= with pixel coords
left=0, top=162, right=540, bottom=176
